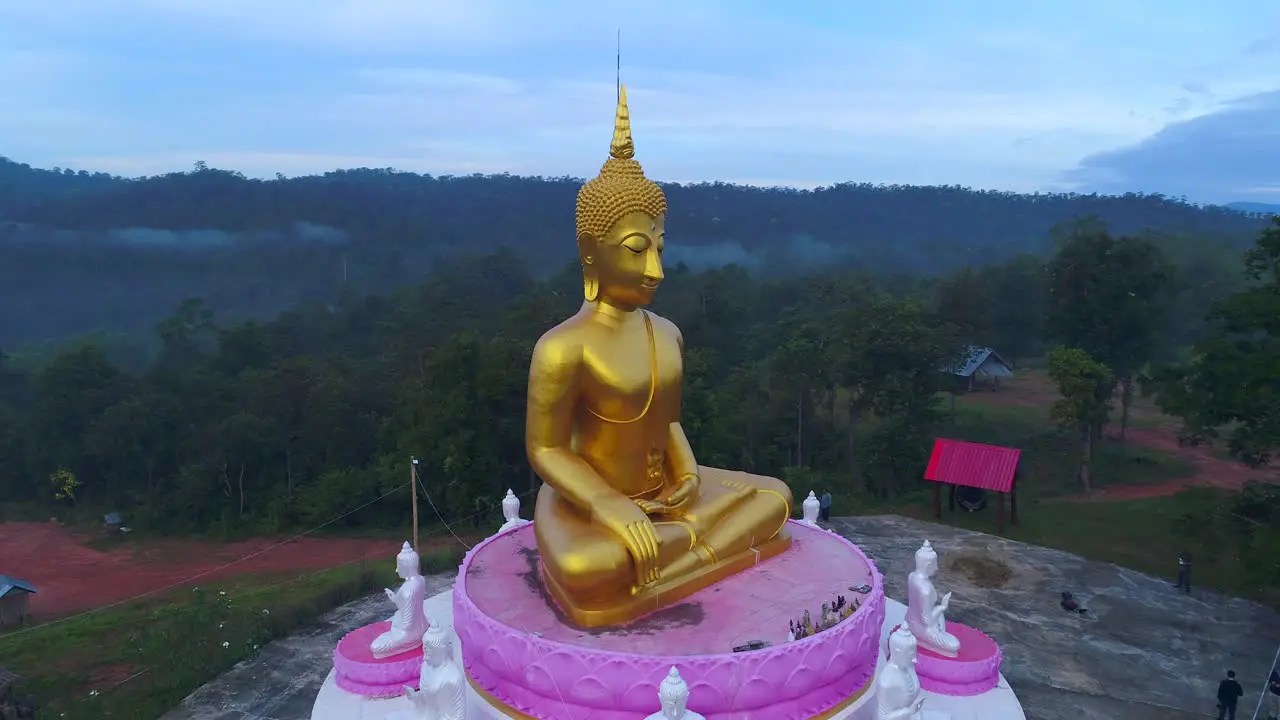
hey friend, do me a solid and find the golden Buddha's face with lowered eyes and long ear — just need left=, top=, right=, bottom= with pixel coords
left=579, top=213, right=667, bottom=307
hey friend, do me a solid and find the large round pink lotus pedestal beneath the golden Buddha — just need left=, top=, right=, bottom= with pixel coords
left=453, top=523, right=884, bottom=720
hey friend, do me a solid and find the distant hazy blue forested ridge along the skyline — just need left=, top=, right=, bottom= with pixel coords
left=0, top=159, right=1262, bottom=347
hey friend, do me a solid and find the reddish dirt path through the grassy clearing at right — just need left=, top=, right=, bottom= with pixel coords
left=964, top=373, right=1280, bottom=502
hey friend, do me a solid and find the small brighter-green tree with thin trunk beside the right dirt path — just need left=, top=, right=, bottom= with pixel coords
left=1044, top=345, right=1115, bottom=492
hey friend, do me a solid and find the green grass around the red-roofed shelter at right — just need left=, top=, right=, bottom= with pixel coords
left=835, top=396, right=1280, bottom=607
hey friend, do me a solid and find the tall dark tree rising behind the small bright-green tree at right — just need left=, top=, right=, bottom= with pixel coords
left=1047, top=223, right=1170, bottom=442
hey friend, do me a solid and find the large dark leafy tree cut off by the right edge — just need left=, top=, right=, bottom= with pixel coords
left=1155, top=217, right=1280, bottom=466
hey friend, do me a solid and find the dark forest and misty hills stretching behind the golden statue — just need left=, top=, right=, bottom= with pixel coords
left=0, top=148, right=1280, bottom=614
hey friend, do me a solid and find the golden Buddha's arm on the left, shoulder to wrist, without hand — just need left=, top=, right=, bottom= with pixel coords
left=525, top=337, right=618, bottom=512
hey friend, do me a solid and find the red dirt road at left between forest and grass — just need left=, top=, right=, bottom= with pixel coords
left=0, top=523, right=460, bottom=619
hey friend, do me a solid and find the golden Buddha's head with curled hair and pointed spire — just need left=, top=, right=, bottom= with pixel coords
left=576, top=87, right=667, bottom=307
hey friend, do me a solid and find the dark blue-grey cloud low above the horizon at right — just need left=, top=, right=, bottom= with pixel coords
left=1065, top=91, right=1280, bottom=202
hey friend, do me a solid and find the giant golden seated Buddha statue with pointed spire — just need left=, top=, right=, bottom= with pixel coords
left=525, top=87, right=792, bottom=626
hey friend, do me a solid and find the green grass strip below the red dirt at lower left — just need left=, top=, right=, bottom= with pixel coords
left=0, top=552, right=460, bottom=720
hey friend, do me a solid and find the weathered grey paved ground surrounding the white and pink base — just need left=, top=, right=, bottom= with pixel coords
left=172, top=515, right=1280, bottom=720
